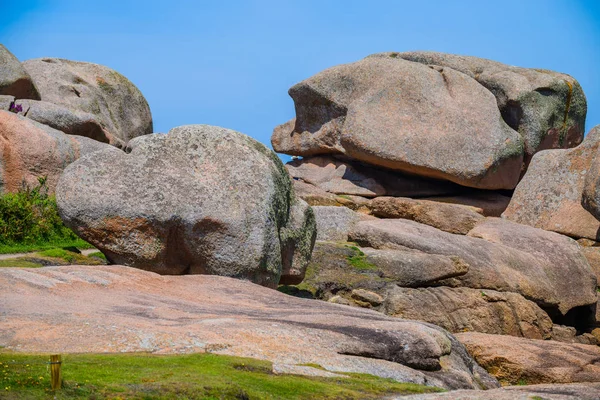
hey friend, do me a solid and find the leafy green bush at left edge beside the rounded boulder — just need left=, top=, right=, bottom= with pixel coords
left=0, top=178, right=78, bottom=246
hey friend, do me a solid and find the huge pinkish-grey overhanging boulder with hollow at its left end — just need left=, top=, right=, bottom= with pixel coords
left=271, top=58, right=523, bottom=189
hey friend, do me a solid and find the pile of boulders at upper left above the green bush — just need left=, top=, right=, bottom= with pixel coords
left=0, top=45, right=152, bottom=193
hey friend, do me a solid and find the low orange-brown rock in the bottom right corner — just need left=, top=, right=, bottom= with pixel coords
left=457, top=332, right=600, bottom=385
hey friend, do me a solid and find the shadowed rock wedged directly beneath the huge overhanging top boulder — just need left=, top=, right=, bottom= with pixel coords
left=286, top=156, right=461, bottom=197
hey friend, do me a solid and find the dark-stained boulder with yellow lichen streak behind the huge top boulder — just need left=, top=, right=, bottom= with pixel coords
left=392, top=52, right=587, bottom=162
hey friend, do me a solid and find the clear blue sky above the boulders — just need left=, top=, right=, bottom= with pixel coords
left=0, top=0, right=600, bottom=151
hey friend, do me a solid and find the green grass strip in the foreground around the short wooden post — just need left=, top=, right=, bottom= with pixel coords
left=0, top=353, right=440, bottom=400
